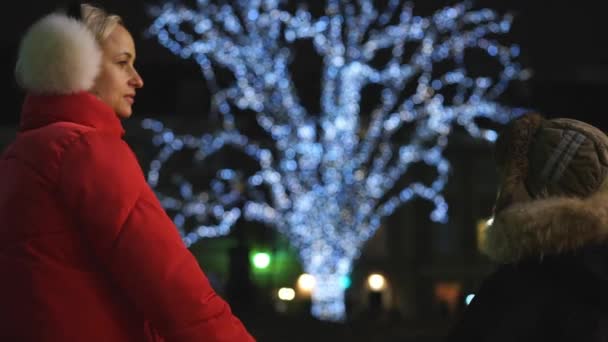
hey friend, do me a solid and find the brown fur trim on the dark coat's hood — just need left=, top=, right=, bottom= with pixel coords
left=482, top=192, right=608, bottom=263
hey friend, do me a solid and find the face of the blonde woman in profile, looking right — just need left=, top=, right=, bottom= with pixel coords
left=91, top=25, right=144, bottom=119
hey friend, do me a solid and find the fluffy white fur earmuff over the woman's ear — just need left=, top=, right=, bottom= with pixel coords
left=15, top=13, right=102, bottom=94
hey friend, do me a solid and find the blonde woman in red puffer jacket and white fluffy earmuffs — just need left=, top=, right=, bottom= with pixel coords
left=0, top=5, right=253, bottom=342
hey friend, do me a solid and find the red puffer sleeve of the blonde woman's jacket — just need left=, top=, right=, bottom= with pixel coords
left=58, top=133, right=253, bottom=342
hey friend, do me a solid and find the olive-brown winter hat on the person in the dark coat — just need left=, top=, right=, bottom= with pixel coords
left=496, top=113, right=608, bottom=211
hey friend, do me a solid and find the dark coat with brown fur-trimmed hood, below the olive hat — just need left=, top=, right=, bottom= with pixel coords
left=447, top=193, right=608, bottom=342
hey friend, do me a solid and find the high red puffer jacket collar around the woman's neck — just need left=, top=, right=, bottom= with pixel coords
left=19, top=92, right=125, bottom=137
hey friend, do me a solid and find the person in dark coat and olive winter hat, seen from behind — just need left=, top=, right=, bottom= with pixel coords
left=447, top=114, right=608, bottom=342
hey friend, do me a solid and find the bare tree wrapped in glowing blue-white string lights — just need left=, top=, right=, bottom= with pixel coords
left=143, top=0, right=523, bottom=321
